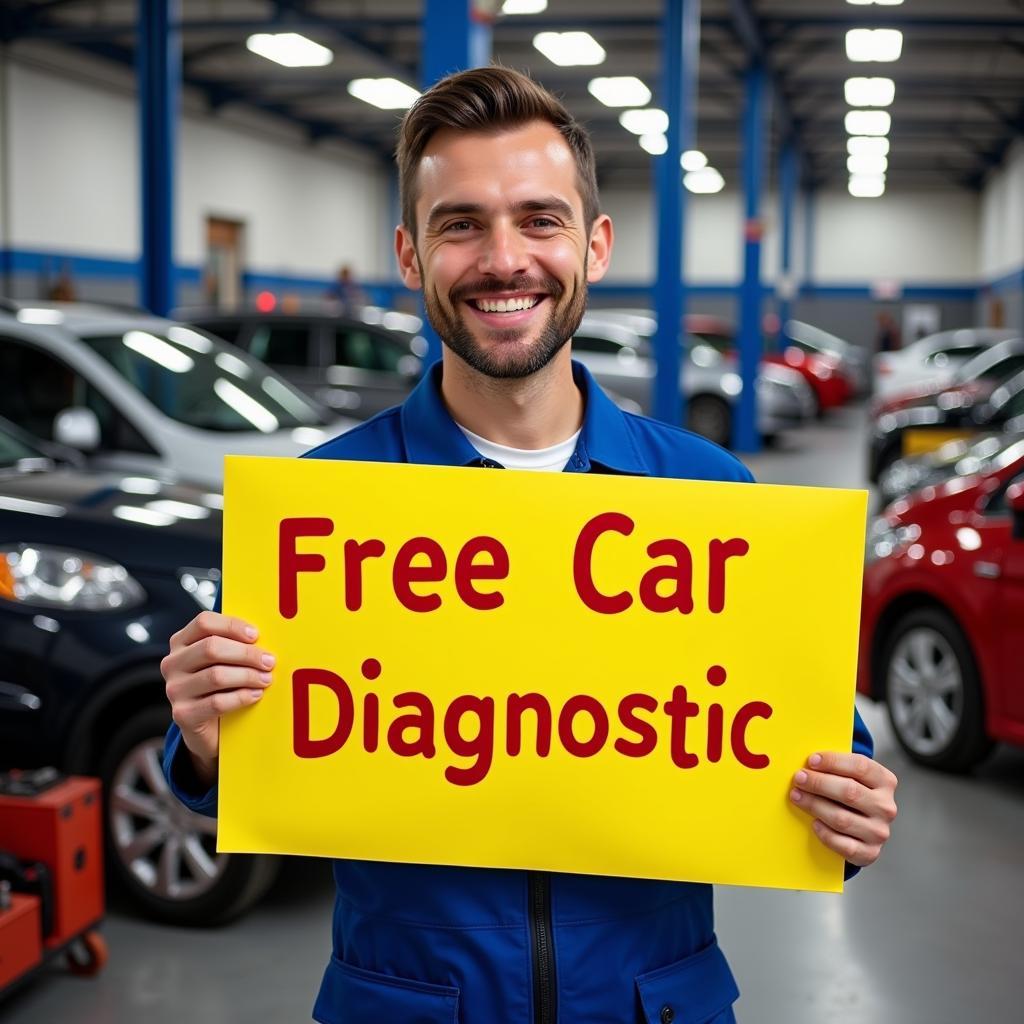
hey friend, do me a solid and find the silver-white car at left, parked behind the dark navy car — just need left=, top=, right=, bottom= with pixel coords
left=0, top=302, right=356, bottom=488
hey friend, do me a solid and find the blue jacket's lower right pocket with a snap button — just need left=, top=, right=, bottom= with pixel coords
left=636, top=942, right=739, bottom=1024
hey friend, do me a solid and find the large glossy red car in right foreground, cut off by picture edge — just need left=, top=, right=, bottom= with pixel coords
left=857, top=442, right=1024, bottom=771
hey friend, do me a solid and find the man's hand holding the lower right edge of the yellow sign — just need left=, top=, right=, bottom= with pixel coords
left=790, top=754, right=897, bottom=867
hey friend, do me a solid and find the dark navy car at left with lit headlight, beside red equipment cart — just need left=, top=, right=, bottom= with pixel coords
left=0, top=411, right=278, bottom=925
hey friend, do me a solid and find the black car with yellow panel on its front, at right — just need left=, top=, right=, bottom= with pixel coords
left=867, top=371, right=1024, bottom=483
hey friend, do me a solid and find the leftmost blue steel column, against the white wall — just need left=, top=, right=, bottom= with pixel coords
left=135, top=0, right=181, bottom=316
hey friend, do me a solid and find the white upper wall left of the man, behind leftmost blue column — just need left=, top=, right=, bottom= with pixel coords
left=7, top=60, right=393, bottom=279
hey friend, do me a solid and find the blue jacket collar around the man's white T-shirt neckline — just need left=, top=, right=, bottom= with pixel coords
left=401, top=361, right=651, bottom=476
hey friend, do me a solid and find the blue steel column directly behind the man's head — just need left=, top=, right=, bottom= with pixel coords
left=420, top=0, right=492, bottom=364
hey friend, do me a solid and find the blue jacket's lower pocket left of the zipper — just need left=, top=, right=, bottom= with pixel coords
left=313, top=956, right=459, bottom=1024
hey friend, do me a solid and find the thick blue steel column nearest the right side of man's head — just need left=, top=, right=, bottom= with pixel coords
left=651, top=0, right=700, bottom=423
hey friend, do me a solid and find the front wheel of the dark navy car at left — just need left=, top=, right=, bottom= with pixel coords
left=99, top=708, right=279, bottom=925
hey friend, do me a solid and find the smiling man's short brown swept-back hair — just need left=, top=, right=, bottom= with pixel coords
left=395, top=67, right=600, bottom=236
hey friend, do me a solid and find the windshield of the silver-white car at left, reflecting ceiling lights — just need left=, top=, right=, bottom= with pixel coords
left=82, top=326, right=328, bottom=433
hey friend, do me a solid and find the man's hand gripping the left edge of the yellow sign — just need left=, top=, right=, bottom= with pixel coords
left=160, top=611, right=274, bottom=785
